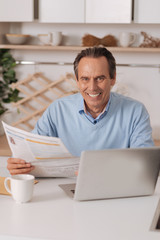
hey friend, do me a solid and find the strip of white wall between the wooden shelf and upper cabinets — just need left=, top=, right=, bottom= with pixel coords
left=6, top=22, right=160, bottom=46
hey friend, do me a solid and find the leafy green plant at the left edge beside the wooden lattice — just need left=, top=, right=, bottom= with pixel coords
left=0, top=49, right=21, bottom=134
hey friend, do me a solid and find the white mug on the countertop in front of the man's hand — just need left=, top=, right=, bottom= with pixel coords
left=4, top=174, right=35, bottom=203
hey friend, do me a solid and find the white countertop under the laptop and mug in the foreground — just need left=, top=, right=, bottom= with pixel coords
left=0, top=155, right=160, bottom=240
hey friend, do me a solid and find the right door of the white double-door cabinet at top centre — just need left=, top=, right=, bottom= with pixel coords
left=86, top=0, right=132, bottom=23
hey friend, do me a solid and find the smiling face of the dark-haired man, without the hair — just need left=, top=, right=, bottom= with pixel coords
left=77, top=57, right=115, bottom=116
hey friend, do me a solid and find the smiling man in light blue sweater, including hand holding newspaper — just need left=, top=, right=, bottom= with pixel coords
left=8, top=47, right=154, bottom=174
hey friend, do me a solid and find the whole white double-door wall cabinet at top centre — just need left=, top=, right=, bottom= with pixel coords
left=39, top=0, right=132, bottom=23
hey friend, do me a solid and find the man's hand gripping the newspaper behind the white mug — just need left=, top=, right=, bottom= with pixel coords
left=7, top=158, right=34, bottom=175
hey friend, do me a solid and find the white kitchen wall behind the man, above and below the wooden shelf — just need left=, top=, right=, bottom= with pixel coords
left=0, top=22, right=160, bottom=139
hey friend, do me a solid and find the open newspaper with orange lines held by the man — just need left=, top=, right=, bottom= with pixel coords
left=2, top=122, right=79, bottom=177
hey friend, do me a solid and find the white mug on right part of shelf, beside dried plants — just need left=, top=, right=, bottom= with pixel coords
left=119, top=32, right=136, bottom=47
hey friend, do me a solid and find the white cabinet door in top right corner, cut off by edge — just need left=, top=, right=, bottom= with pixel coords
left=134, top=0, right=160, bottom=23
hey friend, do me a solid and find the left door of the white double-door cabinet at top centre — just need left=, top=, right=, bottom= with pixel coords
left=39, top=0, right=84, bottom=23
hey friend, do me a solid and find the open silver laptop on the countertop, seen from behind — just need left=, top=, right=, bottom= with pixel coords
left=59, top=147, right=160, bottom=201
